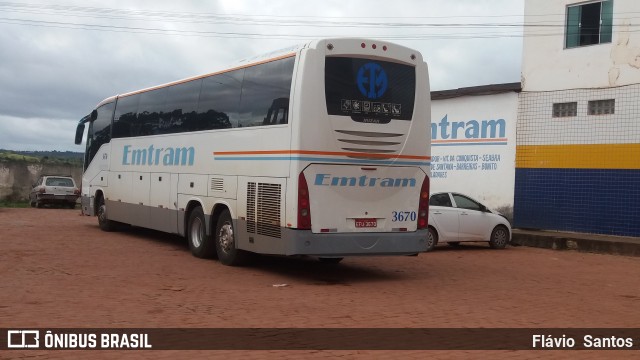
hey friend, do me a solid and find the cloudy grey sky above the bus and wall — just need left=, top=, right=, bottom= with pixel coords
left=0, top=0, right=524, bottom=152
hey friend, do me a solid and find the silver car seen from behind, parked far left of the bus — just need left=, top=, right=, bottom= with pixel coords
left=29, top=175, right=80, bottom=209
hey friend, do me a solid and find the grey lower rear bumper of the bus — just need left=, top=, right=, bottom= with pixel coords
left=282, top=229, right=428, bottom=257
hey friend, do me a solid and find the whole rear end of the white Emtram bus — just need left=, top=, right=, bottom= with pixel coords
left=286, top=39, right=430, bottom=258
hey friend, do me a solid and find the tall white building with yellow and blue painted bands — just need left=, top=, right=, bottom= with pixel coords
left=514, top=0, right=640, bottom=236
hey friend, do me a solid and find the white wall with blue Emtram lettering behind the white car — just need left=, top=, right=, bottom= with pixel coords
left=431, top=83, right=520, bottom=214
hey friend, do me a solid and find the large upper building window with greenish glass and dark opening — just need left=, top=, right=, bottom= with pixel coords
left=565, top=0, right=613, bottom=48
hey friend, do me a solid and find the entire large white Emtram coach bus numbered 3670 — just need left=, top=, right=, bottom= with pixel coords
left=76, top=39, right=431, bottom=265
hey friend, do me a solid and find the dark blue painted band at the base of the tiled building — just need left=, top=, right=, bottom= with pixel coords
left=514, top=168, right=640, bottom=237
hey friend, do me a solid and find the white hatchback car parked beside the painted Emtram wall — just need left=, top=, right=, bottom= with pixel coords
left=427, top=192, right=511, bottom=251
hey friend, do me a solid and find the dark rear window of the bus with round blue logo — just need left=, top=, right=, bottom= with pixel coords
left=324, top=57, right=416, bottom=124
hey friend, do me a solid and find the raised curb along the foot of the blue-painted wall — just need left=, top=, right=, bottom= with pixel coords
left=511, top=229, right=640, bottom=256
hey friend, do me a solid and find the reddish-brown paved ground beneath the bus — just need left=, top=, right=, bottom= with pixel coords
left=0, top=208, right=640, bottom=359
